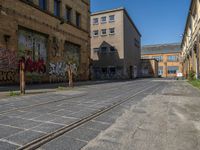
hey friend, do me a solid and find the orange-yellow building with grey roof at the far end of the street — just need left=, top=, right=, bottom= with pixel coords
left=141, top=44, right=182, bottom=77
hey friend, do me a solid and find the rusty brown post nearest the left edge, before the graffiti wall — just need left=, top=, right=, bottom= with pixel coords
left=20, top=61, right=25, bottom=95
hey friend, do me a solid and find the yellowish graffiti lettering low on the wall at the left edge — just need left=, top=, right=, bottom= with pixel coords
left=0, top=71, right=16, bottom=81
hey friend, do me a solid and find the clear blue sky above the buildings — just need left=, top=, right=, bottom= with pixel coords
left=91, top=0, right=190, bottom=45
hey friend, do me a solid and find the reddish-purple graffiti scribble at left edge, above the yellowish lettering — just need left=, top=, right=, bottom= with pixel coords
left=0, top=48, right=17, bottom=69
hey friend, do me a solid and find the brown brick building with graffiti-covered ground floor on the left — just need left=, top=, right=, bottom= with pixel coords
left=0, top=0, right=90, bottom=83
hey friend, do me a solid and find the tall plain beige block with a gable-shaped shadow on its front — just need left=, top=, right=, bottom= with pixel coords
left=91, top=8, right=141, bottom=79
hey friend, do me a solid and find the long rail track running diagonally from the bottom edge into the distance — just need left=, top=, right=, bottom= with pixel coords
left=17, top=84, right=158, bottom=150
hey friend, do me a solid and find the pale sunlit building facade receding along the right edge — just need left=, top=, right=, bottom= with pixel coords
left=181, top=0, right=200, bottom=78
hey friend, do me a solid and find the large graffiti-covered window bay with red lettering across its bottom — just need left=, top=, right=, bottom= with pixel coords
left=18, top=29, right=47, bottom=74
